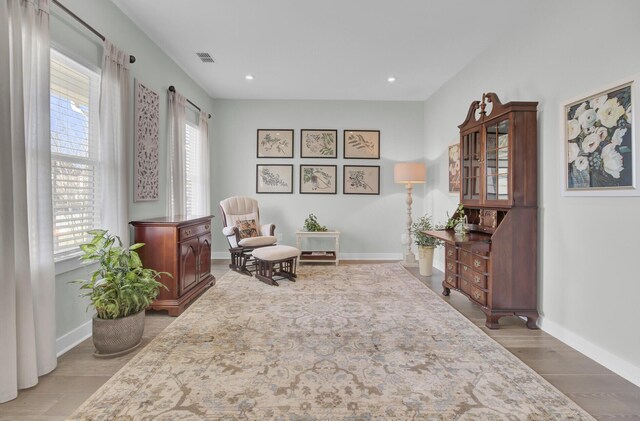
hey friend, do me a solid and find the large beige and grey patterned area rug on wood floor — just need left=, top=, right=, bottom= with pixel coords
left=67, top=264, right=593, bottom=421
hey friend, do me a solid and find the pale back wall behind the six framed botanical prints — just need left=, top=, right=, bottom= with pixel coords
left=211, top=100, right=424, bottom=259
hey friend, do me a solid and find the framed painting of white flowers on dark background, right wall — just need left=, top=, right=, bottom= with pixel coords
left=562, top=74, right=640, bottom=196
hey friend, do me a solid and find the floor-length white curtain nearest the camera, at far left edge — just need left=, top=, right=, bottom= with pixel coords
left=0, top=0, right=57, bottom=402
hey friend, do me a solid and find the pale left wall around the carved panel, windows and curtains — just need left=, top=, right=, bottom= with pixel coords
left=51, top=0, right=213, bottom=351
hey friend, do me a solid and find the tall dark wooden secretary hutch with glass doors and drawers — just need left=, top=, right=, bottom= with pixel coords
left=427, top=93, right=539, bottom=329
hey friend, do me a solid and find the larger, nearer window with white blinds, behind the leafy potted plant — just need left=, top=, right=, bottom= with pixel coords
left=50, top=50, right=100, bottom=261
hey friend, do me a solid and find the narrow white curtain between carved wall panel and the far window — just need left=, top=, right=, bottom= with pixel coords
left=167, top=91, right=187, bottom=216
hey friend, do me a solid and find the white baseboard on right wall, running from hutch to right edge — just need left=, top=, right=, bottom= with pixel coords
left=539, top=317, right=640, bottom=386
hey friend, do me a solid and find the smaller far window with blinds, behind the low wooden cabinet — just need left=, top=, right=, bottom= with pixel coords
left=185, top=121, right=204, bottom=216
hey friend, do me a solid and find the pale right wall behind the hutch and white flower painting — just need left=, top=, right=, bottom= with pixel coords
left=425, top=0, right=640, bottom=385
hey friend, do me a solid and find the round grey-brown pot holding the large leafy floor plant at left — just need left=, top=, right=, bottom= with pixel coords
left=93, top=310, right=145, bottom=358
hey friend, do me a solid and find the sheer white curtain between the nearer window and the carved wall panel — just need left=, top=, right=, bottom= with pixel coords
left=100, top=40, right=131, bottom=244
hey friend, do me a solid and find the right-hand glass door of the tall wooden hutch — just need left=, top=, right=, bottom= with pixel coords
left=484, top=120, right=510, bottom=202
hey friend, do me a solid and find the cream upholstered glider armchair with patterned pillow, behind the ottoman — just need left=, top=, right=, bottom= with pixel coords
left=220, top=196, right=277, bottom=276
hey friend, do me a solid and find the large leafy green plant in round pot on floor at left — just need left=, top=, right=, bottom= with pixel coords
left=74, top=230, right=171, bottom=357
